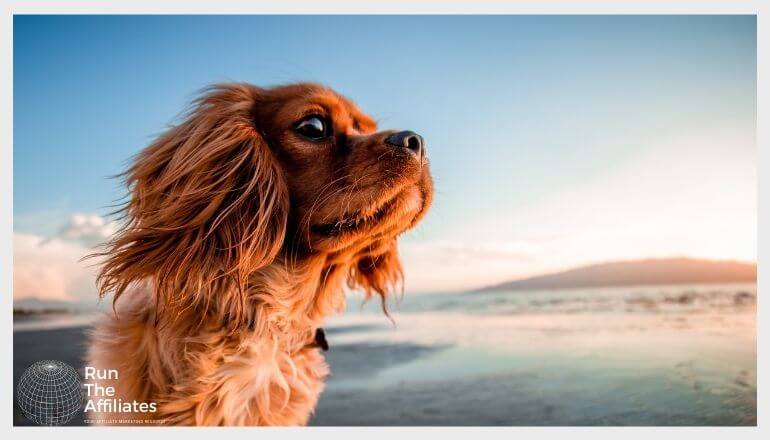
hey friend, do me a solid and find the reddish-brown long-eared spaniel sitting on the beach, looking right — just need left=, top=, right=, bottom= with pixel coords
left=86, top=83, right=433, bottom=426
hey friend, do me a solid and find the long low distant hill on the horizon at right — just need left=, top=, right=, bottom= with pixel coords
left=476, top=258, right=757, bottom=292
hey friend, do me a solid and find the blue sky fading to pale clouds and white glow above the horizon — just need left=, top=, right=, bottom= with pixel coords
left=13, top=16, right=757, bottom=300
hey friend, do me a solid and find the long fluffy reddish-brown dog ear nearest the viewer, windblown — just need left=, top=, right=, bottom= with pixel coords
left=98, top=84, right=289, bottom=318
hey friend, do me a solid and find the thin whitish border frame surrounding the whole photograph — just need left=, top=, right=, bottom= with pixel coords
left=0, top=0, right=770, bottom=440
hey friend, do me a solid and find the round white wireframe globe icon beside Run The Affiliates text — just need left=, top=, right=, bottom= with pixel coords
left=16, top=361, right=83, bottom=426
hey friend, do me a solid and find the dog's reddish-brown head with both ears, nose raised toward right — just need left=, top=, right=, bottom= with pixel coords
left=99, top=84, right=432, bottom=314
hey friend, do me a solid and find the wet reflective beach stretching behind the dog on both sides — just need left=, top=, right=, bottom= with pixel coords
left=14, top=284, right=756, bottom=426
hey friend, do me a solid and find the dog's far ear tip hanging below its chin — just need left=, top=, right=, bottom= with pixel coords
left=348, top=240, right=404, bottom=306
